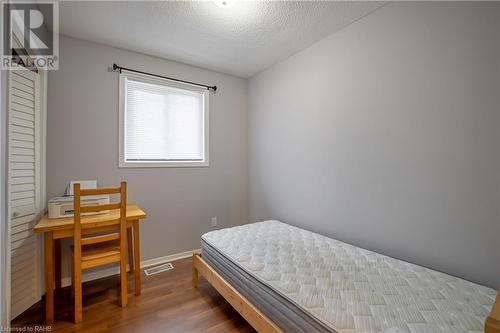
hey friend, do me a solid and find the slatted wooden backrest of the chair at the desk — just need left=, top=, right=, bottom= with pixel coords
left=73, top=182, right=127, bottom=259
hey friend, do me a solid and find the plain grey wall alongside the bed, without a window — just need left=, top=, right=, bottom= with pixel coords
left=248, top=2, right=500, bottom=288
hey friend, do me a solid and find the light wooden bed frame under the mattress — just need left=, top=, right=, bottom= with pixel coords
left=193, top=252, right=500, bottom=333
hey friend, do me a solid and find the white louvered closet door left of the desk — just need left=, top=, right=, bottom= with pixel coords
left=8, top=70, right=41, bottom=318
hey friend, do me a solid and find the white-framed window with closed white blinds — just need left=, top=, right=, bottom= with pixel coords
left=120, top=71, right=208, bottom=167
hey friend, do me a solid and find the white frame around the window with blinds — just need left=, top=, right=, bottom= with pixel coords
left=118, top=70, right=210, bottom=168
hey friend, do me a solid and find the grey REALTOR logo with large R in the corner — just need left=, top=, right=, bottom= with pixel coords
left=1, top=1, right=59, bottom=70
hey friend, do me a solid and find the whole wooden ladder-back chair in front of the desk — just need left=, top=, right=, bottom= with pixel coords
left=71, top=182, right=127, bottom=323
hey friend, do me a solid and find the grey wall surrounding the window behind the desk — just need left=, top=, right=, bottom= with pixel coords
left=47, top=37, right=247, bottom=278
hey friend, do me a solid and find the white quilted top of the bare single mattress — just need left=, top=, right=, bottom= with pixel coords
left=202, top=221, right=496, bottom=333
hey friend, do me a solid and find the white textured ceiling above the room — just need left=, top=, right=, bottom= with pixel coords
left=56, top=1, right=383, bottom=77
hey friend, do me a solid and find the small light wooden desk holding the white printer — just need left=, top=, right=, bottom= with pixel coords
left=33, top=204, right=146, bottom=324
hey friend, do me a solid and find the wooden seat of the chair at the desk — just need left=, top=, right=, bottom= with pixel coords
left=71, top=240, right=120, bottom=269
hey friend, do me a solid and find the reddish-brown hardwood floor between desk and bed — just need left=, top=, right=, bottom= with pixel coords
left=12, top=258, right=255, bottom=333
